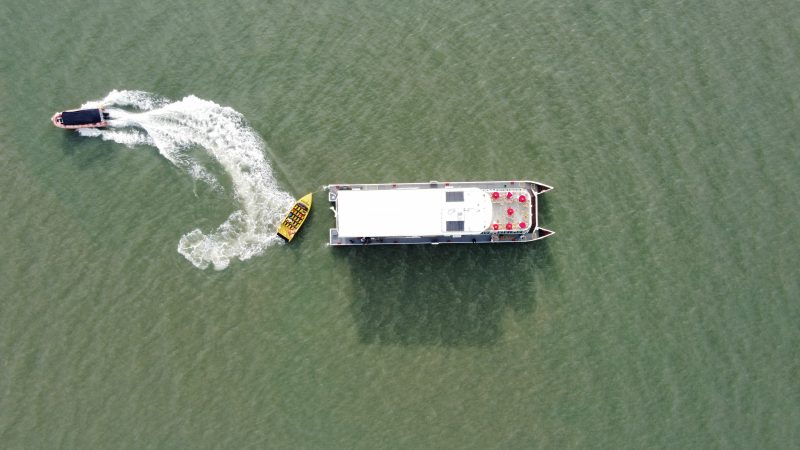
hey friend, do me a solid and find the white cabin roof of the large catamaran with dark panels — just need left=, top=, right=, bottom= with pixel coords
left=336, top=188, right=492, bottom=238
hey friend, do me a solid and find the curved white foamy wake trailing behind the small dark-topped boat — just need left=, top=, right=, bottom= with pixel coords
left=78, top=90, right=293, bottom=270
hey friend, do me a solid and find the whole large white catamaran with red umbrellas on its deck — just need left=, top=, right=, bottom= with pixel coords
left=327, top=181, right=552, bottom=245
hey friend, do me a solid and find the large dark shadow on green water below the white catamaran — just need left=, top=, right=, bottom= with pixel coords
left=336, top=240, right=550, bottom=347
